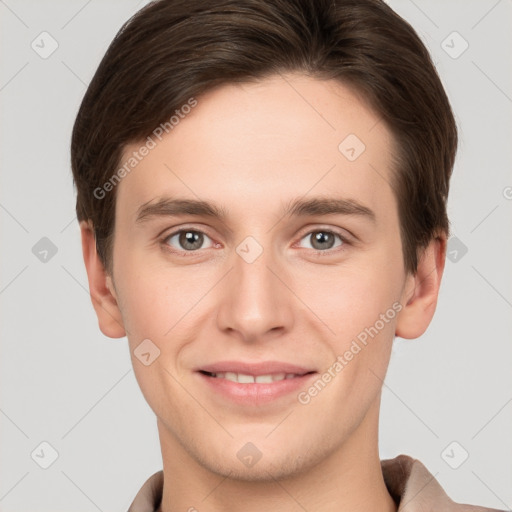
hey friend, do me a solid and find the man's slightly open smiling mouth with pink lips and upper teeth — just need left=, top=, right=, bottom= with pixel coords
left=195, top=362, right=318, bottom=406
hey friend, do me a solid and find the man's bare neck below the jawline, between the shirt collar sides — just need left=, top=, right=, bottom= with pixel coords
left=158, top=397, right=397, bottom=512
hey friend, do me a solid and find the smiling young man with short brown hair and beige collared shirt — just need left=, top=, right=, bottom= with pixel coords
left=72, top=0, right=506, bottom=512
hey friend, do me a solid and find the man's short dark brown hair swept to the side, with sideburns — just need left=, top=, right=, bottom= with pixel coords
left=71, top=0, right=457, bottom=274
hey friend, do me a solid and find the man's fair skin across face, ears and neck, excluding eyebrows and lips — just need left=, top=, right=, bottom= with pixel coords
left=81, top=74, right=446, bottom=512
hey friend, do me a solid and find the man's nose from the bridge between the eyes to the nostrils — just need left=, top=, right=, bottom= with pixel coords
left=217, top=239, right=295, bottom=343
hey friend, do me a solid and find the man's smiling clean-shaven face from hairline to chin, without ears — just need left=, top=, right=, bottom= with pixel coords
left=94, top=75, right=418, bottom=479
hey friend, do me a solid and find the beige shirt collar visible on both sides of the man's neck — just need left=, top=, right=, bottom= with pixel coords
left=128, top=455, right=504, bottom=512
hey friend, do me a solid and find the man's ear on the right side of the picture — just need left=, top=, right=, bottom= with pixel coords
left=395, top=233, right=446, bottom=339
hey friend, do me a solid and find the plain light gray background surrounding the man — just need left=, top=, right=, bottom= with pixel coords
left=0, top=0, right=512, bottom=512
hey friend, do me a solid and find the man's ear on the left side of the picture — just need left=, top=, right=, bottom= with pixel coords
left=80, top=221, right=126, bottom=338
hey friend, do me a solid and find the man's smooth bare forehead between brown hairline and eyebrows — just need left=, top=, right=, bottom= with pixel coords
left=116, top=75, right=394, bottom=224
